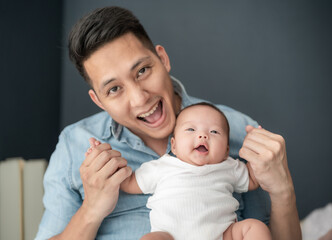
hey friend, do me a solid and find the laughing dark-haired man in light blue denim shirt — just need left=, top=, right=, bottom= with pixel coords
left=37, top=7, right=301, bottom=240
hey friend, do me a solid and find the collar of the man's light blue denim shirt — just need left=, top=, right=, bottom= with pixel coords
left=103, top=76, right=192, bottom=140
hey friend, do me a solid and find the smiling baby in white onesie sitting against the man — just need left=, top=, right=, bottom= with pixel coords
left=88, top=103, right=272, bottom=240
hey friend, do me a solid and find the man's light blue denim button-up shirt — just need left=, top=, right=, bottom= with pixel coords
left=36, top=77, right=270, bottom=240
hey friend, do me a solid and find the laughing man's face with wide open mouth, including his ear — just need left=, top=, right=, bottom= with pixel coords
left=83, top=33, right=180, bottom=141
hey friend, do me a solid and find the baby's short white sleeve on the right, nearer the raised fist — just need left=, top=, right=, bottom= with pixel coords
left=234, top=159, right=249, bottom=193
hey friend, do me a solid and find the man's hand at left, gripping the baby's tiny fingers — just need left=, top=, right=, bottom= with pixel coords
left=80, top=138, right=131, bottom=221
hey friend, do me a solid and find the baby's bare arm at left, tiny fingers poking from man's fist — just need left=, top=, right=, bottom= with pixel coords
left=85, top=138, right=143, bottom=194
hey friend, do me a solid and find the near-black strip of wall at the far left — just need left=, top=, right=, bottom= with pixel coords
left=0, top=0, right=62, bottom=160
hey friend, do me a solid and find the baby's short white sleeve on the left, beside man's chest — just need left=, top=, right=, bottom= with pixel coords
left=135, top=160, right=160, bottom=194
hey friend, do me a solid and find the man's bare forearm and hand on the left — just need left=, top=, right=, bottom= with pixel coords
left=51, top=143, right=131, bottom=240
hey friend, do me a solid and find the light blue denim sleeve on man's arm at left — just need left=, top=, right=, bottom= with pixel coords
left=35, top=132, right=82, bottom=240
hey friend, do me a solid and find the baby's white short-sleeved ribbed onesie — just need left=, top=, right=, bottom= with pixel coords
left=135, top=154, right=249, bottom=240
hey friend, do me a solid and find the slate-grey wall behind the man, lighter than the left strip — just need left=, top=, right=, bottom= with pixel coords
left=61, top=0, right=332, bottom=220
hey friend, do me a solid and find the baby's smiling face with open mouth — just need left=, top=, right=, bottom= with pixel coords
left=171, top=105, right=229, bottom=166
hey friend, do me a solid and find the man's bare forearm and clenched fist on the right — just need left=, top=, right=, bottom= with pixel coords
left=239, top=126, right=301, bottom=240
